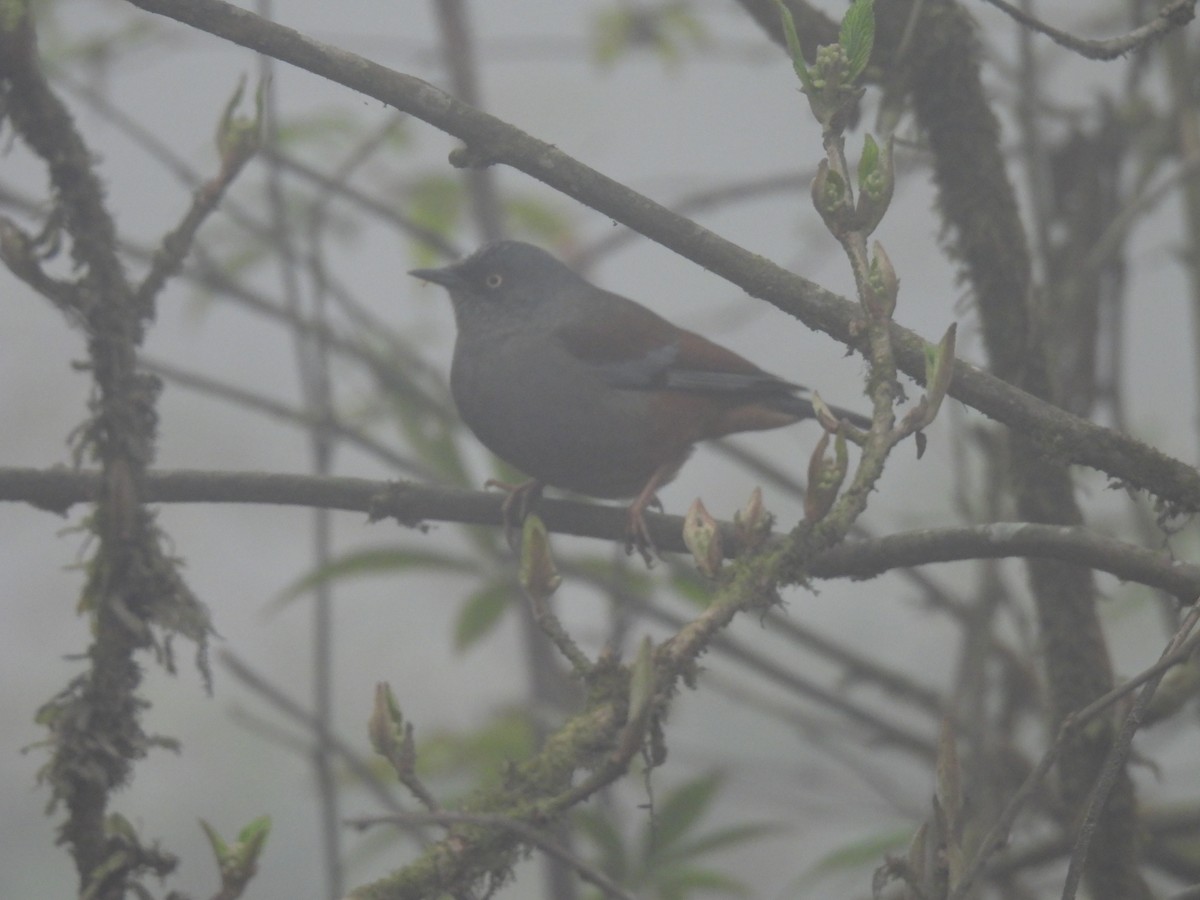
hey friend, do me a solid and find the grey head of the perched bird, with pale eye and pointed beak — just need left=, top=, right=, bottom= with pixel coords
left=409, top=241, right=587, bottom=330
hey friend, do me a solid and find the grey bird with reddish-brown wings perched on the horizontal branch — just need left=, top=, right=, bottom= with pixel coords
left=409, top=240, right=871, bottom=562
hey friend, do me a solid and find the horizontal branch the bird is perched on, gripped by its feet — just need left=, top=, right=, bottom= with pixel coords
left=0, top=468, right=1200, bottom=599
